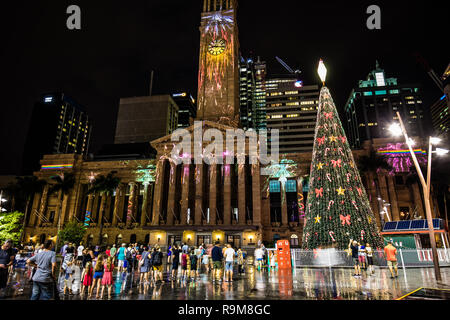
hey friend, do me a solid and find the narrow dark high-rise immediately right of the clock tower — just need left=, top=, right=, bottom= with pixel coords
left=239, top=57, right=267, bottom=130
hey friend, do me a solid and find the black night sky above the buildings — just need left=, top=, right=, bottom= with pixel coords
left=0, top=0, right=450, bottom=174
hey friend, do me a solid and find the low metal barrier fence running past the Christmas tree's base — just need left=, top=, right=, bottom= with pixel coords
left=291, top=249, right=450, bottom=268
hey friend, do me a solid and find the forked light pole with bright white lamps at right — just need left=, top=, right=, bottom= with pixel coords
left=389, top=112, right=448, bottom=282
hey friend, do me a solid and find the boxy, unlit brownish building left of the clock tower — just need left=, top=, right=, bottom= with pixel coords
left=114, top=95, right=178, bottom=144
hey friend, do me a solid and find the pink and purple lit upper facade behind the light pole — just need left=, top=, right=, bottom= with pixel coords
left=377, top=143, right=427, bottom=174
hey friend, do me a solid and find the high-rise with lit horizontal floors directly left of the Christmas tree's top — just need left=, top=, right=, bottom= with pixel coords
left=266, top=78, right=320, bottom=153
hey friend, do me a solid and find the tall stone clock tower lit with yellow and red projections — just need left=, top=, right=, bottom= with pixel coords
left=197, top=0, right=239, bottom=127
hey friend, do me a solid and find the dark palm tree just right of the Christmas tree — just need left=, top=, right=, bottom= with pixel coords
left=358, top=149, right=392, bottom=222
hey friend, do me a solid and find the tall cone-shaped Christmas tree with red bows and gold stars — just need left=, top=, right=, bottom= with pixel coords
left=303, top=86, right=383, bottom=250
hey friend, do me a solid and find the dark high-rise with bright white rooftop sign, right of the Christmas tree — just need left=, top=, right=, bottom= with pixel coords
left=345, top=61, right=426, bottom=148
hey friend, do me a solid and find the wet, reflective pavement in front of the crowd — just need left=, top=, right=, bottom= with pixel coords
left=5, top=266, right=450, bottom=300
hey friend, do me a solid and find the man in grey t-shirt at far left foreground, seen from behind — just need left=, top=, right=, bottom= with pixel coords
left=27, top=240, right=57, bottom=300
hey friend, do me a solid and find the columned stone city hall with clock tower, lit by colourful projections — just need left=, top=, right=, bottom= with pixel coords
left=24, top=0, right=444, bottom=250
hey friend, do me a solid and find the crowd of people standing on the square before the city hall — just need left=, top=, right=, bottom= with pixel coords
left=0, top=240, right=404, bottom=300
